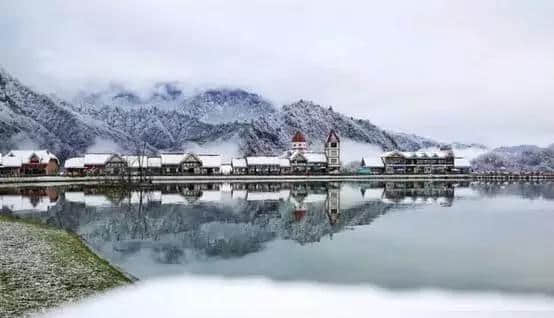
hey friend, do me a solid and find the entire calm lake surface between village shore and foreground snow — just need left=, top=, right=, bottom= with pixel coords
left=0, top=182, right=554, bottom=296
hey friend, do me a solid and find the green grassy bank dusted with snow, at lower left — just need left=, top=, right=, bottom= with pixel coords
left=0, top=214, right=133, bottom=317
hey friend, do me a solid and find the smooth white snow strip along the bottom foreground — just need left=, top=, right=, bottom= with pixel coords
left=38, top=277, right=554, bottom=318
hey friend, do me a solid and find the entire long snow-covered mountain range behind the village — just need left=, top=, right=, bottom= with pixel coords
left=0, top=67, right=484, bottom=160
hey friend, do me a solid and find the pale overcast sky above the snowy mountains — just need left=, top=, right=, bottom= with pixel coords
left=0, top=0, right=554, bottom=146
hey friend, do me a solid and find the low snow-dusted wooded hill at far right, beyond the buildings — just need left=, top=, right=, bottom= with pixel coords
left=472, top=144, right=554, bottom=172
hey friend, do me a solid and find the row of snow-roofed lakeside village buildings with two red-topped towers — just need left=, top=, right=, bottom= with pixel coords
left=0, top=130, right=471, bottom=177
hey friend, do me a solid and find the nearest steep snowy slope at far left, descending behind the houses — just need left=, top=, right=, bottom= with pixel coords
left=0, top=68, right=144, bottom=158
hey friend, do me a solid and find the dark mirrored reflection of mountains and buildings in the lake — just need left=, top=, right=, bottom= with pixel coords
left=3, top=182, right=500, bottom=263
